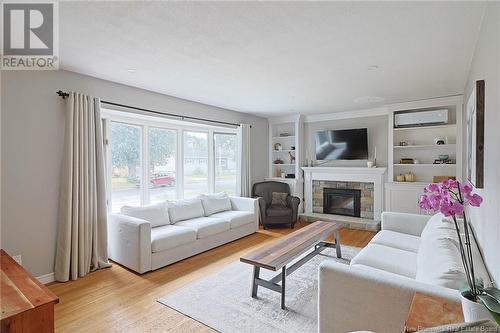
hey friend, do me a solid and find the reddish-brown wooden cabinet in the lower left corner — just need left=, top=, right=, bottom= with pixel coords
left=0, top=250, right=59, bottom=333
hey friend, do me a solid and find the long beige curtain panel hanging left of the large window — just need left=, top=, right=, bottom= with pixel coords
left=55, top=92, right=110, bottom=281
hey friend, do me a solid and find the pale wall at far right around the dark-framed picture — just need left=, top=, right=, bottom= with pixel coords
left=464, top=3, right=500, bottom=284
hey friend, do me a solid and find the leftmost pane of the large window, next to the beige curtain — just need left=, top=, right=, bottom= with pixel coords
left=110, top=122, right=142, bottom=212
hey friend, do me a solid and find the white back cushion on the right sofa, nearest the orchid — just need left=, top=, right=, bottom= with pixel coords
left=415, top=238, right=466, bottom=289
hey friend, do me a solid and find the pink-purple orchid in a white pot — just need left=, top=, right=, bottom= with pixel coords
left=419, top=179, right=500, bottom=324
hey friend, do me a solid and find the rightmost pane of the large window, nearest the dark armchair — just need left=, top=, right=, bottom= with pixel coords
left=214, top=133, right=238, bottom=195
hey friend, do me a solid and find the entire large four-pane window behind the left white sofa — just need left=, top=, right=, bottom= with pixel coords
left=103, top=110, right=239, bottom=212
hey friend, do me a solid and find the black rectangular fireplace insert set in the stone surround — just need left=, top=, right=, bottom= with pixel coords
left=323, top=188, right=361, bottom=217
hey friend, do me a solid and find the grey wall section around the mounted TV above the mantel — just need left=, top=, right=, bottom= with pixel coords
left=305, top=116, right=388, bottom=167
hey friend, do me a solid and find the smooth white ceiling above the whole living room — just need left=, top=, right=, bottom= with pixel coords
left=59, top=2, right=484, bottom=116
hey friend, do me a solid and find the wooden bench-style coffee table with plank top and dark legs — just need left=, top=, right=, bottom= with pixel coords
left=240, top=221, right=342, bottom=309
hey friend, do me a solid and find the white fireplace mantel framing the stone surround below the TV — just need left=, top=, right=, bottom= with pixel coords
left=302, top=167, right=386, bottom=222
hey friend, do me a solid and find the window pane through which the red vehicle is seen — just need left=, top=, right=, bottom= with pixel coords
left=148, top=128, right=177, bottom=203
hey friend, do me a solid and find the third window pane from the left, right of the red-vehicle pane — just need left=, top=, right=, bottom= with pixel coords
left=183, top=132, right=208, bottom=198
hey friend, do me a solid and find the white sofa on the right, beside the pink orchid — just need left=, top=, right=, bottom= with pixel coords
left=318, top=212, right=489, bottom=333
